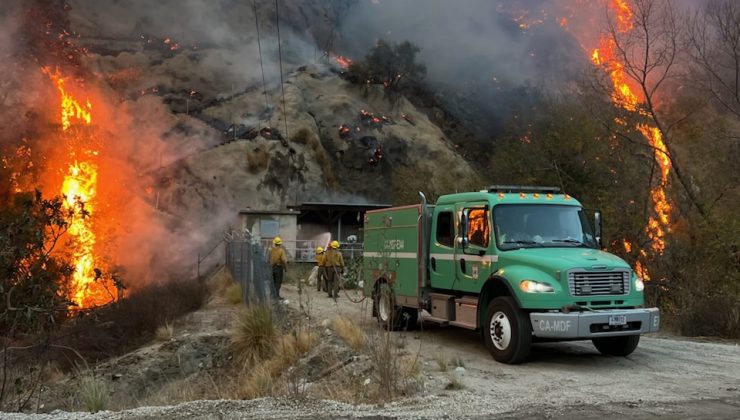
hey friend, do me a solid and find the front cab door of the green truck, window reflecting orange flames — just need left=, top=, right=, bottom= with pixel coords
left=455, top=203, right=498, bottom=293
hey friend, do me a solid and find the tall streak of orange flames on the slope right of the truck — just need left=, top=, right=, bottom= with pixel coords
left=591, top=0, right=692, bottom=278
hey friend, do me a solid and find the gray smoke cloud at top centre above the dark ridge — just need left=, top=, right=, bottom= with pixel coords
left=338, top=0, right=592, bottom=137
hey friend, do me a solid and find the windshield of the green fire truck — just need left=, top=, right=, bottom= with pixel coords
left=493, top=204, right=598, bottom=250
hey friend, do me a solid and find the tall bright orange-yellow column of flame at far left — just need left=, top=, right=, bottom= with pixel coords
left=42, top=67, right=116, bottom=308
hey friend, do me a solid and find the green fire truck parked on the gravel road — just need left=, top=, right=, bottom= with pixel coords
left=362, top=185, right=660, bottom=363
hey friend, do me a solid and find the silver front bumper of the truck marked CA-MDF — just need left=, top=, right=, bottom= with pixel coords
left=529, top=308, right=660, bottom=339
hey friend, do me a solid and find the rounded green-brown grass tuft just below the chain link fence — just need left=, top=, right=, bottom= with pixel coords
left=232, top=305, right=278, bottom=364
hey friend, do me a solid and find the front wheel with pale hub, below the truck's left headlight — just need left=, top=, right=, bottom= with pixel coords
left=482, top=296, right=532, bottom=364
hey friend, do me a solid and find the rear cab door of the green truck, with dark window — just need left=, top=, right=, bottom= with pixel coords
left=429, top=205, right=457, bottom=289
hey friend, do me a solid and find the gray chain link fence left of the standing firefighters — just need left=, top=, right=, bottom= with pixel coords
left=224, top=233, right=275, bottom=304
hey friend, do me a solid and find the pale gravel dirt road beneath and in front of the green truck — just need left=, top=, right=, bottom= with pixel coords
left=7, top=285, right=740, bottom=420
